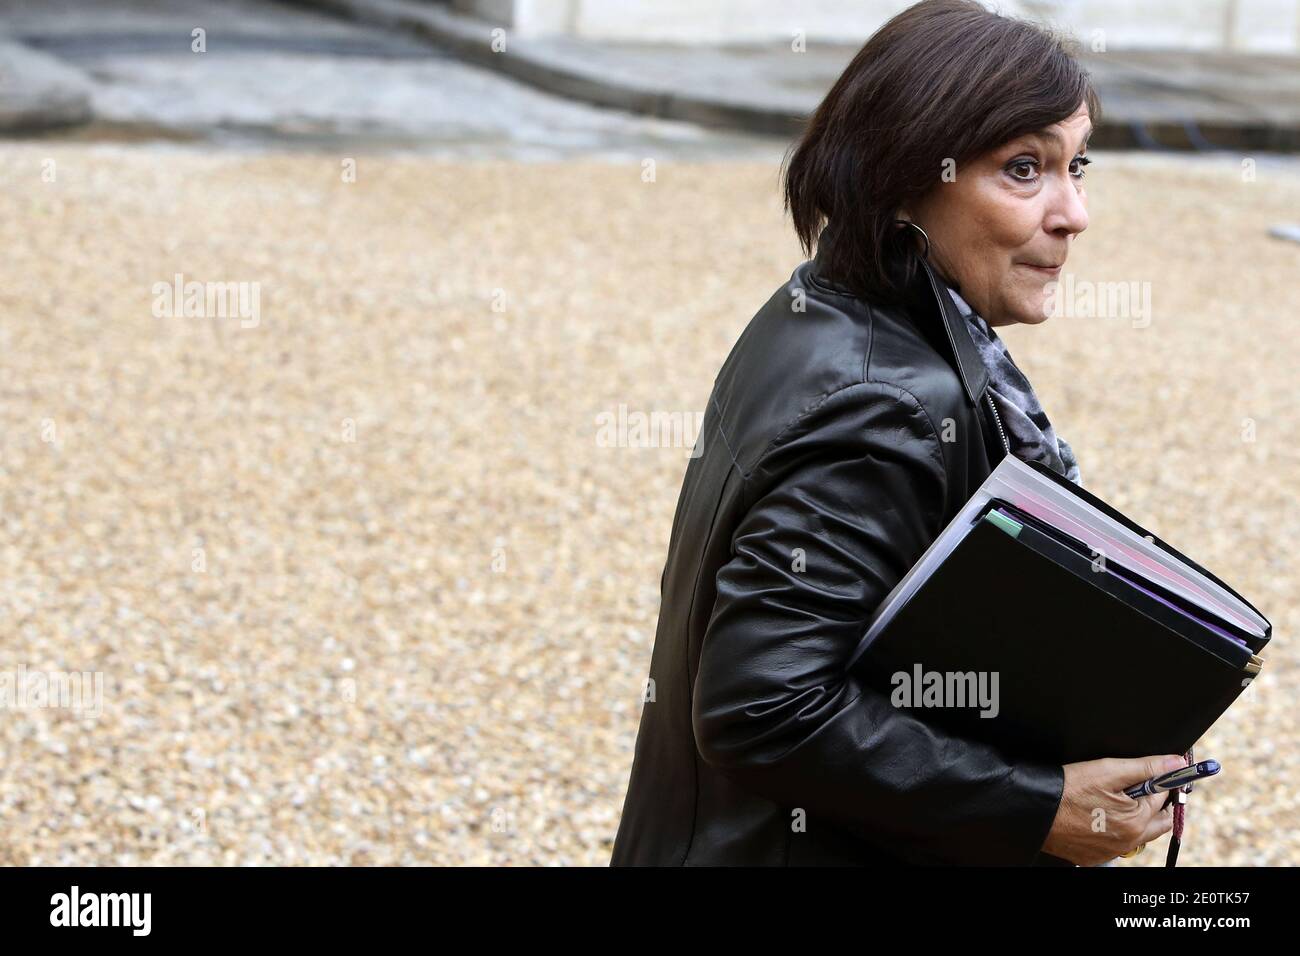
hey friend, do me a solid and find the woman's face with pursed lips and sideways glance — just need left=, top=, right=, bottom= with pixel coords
left=904, top=105, right=1092, bottom=325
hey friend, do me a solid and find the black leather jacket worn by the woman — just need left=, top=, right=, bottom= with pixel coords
left=611, top=234, right=1063, bottom=865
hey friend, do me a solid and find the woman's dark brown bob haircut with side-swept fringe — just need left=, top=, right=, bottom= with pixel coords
left=784, top=0, right=1101, bottom=302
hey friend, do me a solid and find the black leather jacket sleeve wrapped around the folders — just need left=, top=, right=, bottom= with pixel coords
left=692, top=382, right=1063, bottom=865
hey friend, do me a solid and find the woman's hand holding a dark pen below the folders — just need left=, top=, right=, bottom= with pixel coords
left=1043, top=756, right=1187, bottom=866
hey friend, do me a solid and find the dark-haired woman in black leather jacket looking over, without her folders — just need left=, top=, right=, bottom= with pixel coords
left=611, top=0, right=1183, bottom=865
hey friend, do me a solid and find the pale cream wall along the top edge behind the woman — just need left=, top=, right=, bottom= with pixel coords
left=451, top=0, right=1300, bottom=53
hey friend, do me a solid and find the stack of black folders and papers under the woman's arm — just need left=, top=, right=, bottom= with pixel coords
left=850, top=455, right=1273, bottom=763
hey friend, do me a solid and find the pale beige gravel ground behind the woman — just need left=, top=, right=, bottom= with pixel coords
left=0, top=143, right=1300, bottom=865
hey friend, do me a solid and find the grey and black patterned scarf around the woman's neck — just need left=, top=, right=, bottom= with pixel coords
left=948, top=286, right=1083, bottom=485
